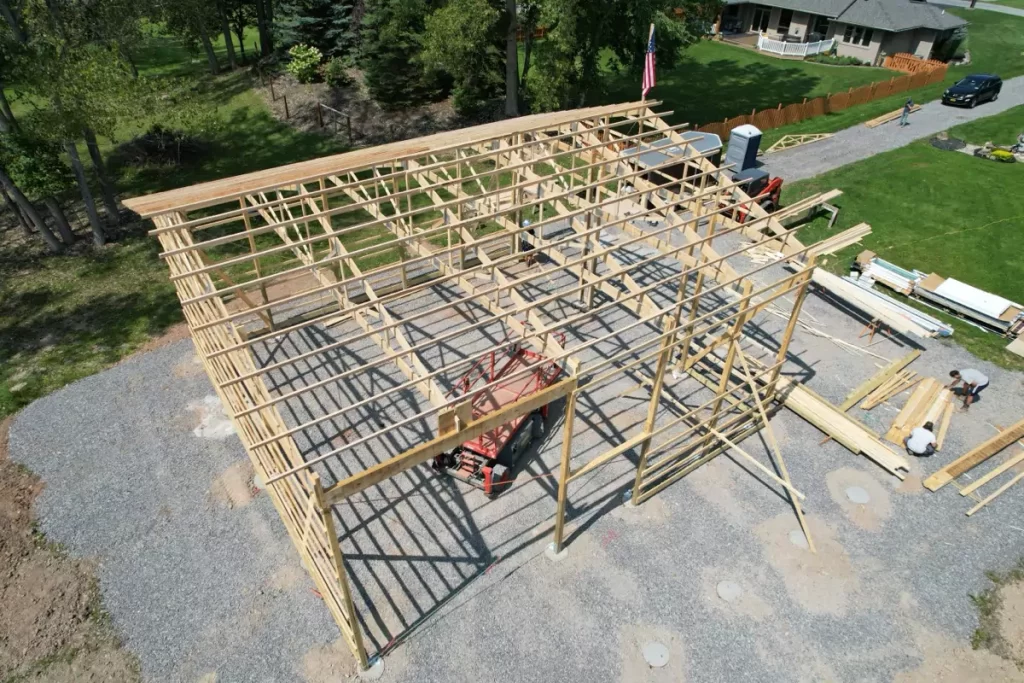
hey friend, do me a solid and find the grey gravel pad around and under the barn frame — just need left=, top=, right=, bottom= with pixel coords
left=10, top=223, right=1024, bottom=683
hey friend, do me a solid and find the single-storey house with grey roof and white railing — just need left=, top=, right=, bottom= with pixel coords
left=722, top=0, right=967, bottom=65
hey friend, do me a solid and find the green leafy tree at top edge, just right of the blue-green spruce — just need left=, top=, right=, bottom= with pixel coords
left=359, top=0, right=447, bottom=109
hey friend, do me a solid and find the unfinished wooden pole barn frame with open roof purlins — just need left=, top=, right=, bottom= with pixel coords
left=126, top=102, right=864, bottom=669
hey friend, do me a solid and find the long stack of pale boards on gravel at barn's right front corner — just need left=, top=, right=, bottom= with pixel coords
left=776, top=377, right=908, bottom=479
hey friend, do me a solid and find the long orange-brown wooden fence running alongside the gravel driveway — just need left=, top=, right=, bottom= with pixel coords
left=697, top=62, right=946, bottom=139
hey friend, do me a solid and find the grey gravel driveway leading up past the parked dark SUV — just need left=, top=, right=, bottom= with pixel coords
left=762, top=76, right=1024, bottom=181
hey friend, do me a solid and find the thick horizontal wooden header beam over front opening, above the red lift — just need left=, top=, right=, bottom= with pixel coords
left=324, top=378, right=577, bottom=505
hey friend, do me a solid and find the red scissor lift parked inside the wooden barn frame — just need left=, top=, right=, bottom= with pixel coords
left=433, top=334, right=565, bottom=497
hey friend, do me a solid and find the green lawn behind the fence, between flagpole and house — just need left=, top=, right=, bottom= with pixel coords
left=600, top=40, right=898, bottom=127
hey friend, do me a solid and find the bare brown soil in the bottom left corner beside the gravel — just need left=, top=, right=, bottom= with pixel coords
left=0, top=418, right=140, bottom=683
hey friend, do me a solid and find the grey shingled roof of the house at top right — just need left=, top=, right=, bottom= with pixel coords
left=726, top=0, right=967, bottom=31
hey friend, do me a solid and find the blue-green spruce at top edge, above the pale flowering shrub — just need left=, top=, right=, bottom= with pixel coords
left=274, top=0, right=353, bottom=57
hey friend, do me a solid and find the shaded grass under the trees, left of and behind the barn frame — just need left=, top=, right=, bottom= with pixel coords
left=0, top=28, right=342, bottom=418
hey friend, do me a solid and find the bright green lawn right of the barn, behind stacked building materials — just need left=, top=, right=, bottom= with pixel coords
left=783, top=106, right=1024, bottom=370
